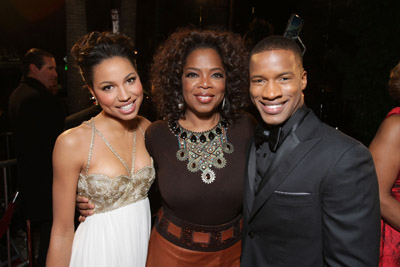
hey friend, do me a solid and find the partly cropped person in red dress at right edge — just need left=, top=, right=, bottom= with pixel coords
left=369, top=63, right=400, bottom=267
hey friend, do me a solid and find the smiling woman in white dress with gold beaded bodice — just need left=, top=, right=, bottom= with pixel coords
left=47, top=32, right=155, bottom=267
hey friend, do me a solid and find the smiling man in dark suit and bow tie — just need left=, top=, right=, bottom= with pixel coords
left=241, top=36, right=380, bottom=267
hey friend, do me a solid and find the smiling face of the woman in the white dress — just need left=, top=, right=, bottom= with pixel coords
left=89, top=57, right=143, bottom=120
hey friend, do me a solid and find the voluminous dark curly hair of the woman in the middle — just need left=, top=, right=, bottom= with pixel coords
left=150, top=27, right=249, bottom=125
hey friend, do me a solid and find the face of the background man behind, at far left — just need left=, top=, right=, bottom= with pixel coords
left=30, top=56, right=57, bottom=89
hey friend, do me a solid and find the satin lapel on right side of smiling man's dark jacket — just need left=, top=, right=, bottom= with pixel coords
left=249, top=111, right=320, bottom=220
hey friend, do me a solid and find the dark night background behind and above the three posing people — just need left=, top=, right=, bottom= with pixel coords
left=0, top=0, right=400, bottom=145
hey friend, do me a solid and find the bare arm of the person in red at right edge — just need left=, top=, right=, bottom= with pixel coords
left=369, top=115, right=400, bottom=231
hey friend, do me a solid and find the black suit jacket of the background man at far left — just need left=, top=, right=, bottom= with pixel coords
left=9, top=77, right=65, bottom=221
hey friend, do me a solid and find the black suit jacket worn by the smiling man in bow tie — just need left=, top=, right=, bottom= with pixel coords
left=241, top=111, right=380, bottom=267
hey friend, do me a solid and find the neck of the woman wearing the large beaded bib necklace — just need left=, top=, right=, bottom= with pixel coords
left=179, top=112, right=221, bottom=132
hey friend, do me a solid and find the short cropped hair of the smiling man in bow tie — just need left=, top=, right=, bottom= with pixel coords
left=249, top=35, right=303, bottom=66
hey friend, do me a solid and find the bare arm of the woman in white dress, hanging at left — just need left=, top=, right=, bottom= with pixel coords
left=46, top=131, right=82, bottom=267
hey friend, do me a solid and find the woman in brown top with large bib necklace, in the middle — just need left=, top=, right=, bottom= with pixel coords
left=146, top=28, right=255, bottom=267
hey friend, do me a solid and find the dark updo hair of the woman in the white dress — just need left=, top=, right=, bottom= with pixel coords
left=71, top=31, right=137, bottom=86
